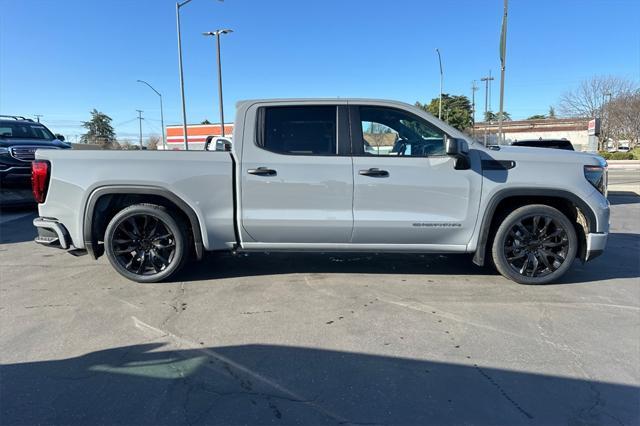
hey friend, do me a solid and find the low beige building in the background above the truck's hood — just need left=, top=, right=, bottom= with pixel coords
left=474, top=118, right=589, bottom=151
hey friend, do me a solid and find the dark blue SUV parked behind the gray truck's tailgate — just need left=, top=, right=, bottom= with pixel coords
left=0, top=115, right=71, bottom=181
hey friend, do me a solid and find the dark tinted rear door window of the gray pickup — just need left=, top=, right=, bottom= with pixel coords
left=257, top=106, right=337, bottom=155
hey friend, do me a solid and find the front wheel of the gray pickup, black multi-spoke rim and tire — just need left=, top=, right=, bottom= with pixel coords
left=491, top=204, right=578, bottom=284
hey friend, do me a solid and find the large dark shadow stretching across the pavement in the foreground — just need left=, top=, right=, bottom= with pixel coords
left=0, top=341, right=640, bottom=425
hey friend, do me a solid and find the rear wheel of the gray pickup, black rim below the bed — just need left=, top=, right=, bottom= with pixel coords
left=104, top=204, right=189, bottom=283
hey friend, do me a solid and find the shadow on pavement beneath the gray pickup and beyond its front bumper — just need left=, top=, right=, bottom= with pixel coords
left=175, top=233, right=640, bottom=285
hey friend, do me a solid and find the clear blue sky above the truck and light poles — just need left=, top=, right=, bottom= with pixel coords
left=0, top=0, right=640, bottom=140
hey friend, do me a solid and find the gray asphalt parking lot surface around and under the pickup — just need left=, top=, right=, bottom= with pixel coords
left=0, top=186, right=640, bottom=425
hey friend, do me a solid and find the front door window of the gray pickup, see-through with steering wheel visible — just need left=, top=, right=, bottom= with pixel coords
left=360, top=106, right=445, bottom=157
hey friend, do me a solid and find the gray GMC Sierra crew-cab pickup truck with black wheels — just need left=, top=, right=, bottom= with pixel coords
left=32, top=99, right=609, bottom=284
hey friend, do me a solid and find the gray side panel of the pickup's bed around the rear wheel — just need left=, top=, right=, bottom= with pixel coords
left=36, top=150, right=235, bottom=250
